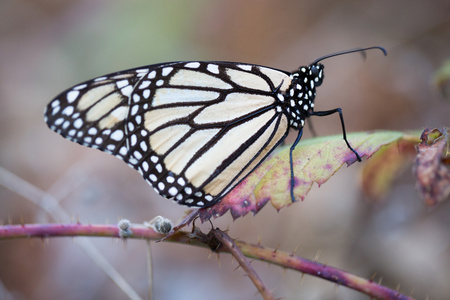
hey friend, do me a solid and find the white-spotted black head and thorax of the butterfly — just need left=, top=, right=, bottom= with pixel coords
left=283, top=64, right=323, bottom=129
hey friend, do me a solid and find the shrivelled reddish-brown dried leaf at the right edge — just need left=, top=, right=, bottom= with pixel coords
left=414, top=128, right=450, bottom=206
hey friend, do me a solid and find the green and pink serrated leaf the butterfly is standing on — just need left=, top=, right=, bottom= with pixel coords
left=199, top=131, right=405, bottom=220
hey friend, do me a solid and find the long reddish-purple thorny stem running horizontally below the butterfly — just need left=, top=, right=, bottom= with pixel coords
left=0, top=224, right=413, bottom=300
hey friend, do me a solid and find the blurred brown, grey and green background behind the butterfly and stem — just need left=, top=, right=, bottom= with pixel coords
left=0, top=0, right=450, bottom=299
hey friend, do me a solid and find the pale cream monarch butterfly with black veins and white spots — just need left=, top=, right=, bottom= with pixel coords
left=45, top=47, right=386, bottom=208
